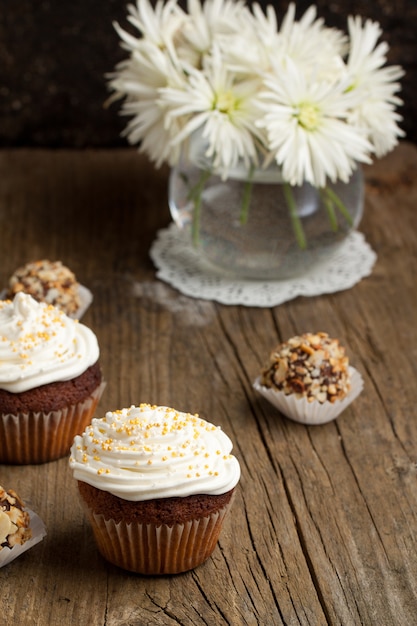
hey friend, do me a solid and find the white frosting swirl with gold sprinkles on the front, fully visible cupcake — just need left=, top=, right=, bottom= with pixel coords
left=70, top=404, right=240, bottom=501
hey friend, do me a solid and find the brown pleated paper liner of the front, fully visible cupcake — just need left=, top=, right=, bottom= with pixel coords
left=83, top=498, right=233, bottom=575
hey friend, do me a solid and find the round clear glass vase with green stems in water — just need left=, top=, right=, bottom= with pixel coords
left=168, top=154, right=363, bottom=280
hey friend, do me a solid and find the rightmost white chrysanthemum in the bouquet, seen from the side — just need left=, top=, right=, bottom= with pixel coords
left=346, top=17, right=404, bottom=157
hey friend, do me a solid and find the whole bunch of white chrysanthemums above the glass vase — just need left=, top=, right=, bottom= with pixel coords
left=109, top=0, right=403, bottom=187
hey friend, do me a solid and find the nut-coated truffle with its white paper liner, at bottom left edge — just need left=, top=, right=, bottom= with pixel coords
left=0, top=487, right=46, bottom=567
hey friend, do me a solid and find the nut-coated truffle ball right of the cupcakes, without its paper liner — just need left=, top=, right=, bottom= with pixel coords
left=260, top=332, right=350, bottom=403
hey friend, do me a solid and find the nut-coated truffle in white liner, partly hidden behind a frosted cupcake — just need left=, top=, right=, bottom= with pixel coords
left=4, top=259, right=91, bottom=317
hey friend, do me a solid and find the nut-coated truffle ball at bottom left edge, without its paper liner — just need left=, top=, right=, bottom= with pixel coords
left=0, top=487, right=32, bottom=550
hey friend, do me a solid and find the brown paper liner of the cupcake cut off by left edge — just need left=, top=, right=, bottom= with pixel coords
left=0, top=382, right=106, bottom=465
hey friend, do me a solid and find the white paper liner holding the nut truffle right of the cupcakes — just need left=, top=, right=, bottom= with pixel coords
left=253, top=367, right=363, bottom=426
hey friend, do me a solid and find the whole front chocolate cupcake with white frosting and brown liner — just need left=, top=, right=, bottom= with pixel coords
left=70, top=404, right=240, bottom=575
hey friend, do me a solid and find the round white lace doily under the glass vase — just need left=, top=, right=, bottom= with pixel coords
left=150, top=223, right=376, bottom=307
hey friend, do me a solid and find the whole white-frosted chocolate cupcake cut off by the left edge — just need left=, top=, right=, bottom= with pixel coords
left=0, top=292, right=104, bottom=464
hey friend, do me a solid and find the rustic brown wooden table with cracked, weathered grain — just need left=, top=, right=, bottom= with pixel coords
left=0, top=143, right=417, bottom=626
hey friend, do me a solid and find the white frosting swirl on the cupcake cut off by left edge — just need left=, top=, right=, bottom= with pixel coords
left=0, top=293, right=99, bottom=393
